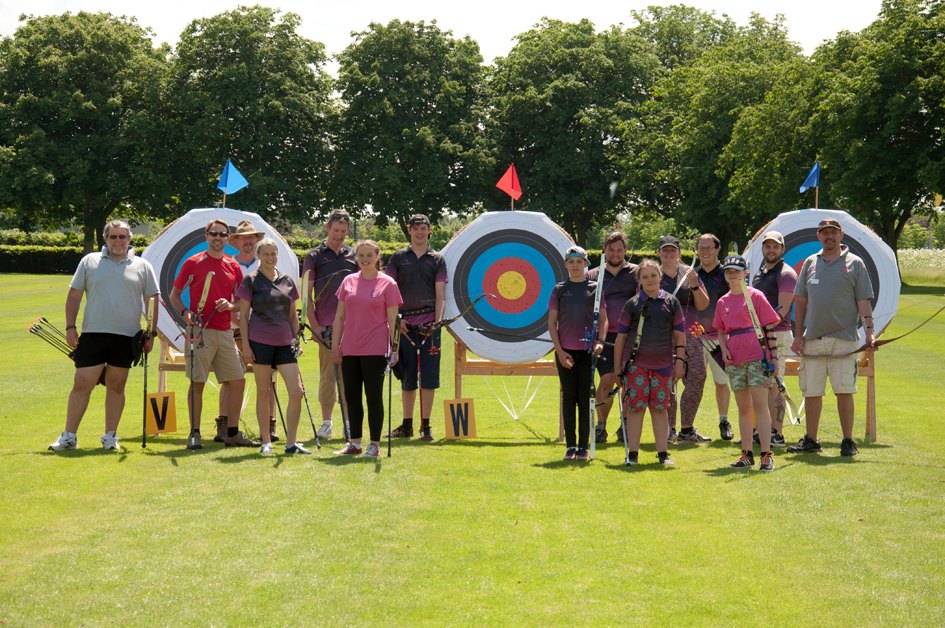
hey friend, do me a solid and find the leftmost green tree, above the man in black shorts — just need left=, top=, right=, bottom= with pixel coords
left=0, top=12, right=168, bottom=250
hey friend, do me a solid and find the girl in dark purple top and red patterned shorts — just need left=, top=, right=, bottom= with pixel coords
left=613, top=259, right=684, bottom=466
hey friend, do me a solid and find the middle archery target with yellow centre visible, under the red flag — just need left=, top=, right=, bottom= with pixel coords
left=442, top=211, right=574, bottom=364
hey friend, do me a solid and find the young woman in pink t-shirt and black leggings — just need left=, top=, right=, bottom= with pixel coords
left=331, top=240, right=403, bottom=458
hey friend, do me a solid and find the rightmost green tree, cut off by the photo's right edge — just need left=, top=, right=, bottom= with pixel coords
left=812, top=0, right=945, bottom=248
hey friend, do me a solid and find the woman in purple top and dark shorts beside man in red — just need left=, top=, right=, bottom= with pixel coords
left=236, top=238, right=312, bottom=456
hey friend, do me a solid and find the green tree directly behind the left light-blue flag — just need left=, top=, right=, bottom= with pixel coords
left=166, top=6, right=331, bottom=220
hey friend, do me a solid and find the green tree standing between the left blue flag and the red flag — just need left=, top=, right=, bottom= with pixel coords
left=332, top=20, right=492, bottom=233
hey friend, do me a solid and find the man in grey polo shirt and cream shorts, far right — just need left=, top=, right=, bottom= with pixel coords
left=788, top=219, right=874, bottom=456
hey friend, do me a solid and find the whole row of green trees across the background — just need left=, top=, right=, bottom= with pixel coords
left=0, top=0, right=945, bottom=249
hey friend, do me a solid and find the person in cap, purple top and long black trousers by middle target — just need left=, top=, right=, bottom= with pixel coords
left=548, top=246, right=607, bottom=460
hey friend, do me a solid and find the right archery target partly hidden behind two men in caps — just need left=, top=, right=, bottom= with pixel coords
left=745, top=209, right=902, bottom=344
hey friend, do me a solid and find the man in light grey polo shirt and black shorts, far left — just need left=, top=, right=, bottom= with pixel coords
left=49, top=220, right=158, bottom=451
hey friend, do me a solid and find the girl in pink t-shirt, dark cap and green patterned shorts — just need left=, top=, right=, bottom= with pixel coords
left=712, top=255, right=781, bottom=471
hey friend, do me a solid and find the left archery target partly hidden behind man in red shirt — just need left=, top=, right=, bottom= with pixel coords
left=141, top=207, right=301, bottom=351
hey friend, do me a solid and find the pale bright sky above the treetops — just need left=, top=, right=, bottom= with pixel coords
left=0, top=0, right=881, bottom=71
